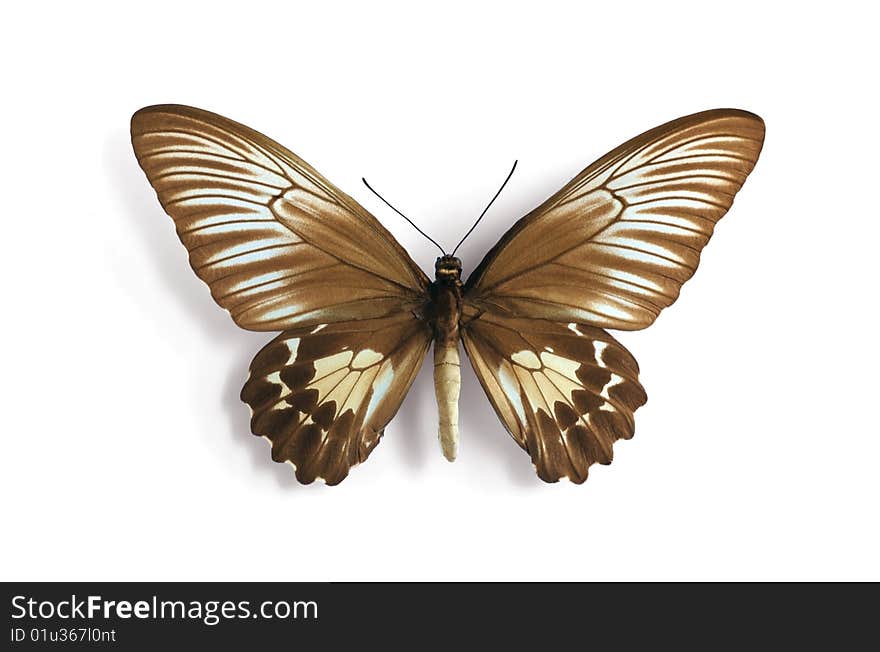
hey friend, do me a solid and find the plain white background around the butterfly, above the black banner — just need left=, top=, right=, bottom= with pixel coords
left=0, top=0, right=880, bottom=580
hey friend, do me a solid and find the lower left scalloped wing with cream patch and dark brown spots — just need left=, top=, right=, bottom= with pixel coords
left=241, top=314, right=431, bottom=484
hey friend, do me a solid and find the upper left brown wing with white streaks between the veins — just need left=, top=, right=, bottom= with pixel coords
left=131, top=105, right=428, bottom=331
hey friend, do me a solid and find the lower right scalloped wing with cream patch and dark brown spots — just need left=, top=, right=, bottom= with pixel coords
left=462, top=313, right=647, bottom=483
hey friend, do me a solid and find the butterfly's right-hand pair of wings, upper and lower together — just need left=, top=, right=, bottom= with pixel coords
left=462, top=109, right=764, bottom=482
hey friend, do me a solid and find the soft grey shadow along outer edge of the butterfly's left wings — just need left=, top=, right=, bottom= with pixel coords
left=103, top=129, right=304, bottom=488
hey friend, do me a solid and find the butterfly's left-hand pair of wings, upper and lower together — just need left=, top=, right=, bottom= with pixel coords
left=131, top=106, right=431, bottom=484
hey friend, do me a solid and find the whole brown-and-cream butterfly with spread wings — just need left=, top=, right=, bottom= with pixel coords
left=131, top=105, right=764, bottom=485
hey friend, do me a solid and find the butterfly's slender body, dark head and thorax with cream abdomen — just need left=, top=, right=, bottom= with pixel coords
left=431, top=256, right=461, bottom=462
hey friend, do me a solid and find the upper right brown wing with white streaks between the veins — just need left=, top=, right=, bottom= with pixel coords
left=466, top=109, right=764, bottom=330
